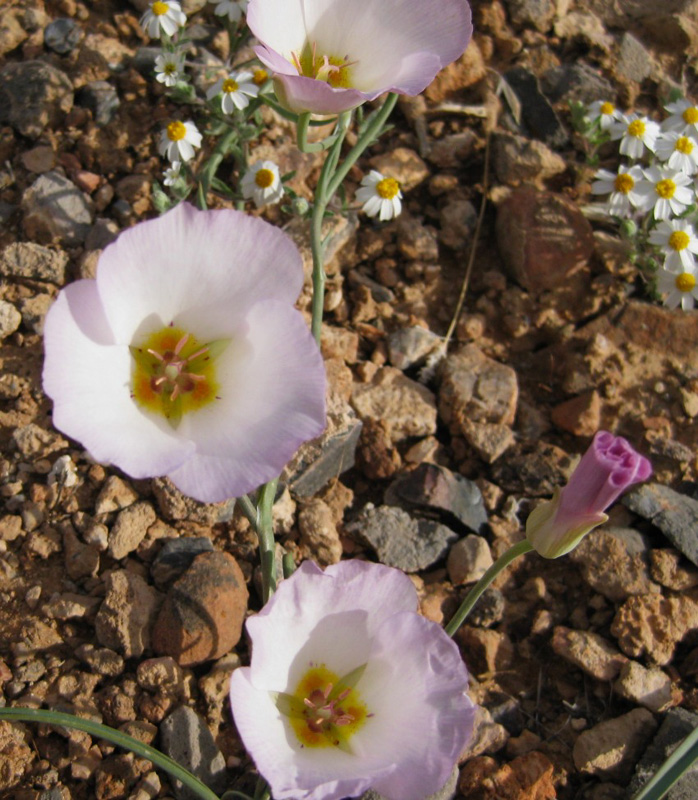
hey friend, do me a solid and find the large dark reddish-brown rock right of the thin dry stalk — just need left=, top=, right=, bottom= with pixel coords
left=497, top=188, right=594, bottom=292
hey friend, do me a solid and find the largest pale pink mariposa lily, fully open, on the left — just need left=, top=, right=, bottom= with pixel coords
left=43, top=203, right=325, bottom=502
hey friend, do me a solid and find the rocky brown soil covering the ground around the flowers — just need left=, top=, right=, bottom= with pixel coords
left=0, top=0, right=698, bottom=800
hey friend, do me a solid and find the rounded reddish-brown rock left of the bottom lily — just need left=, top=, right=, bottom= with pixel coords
left=153, top=552, right=248, bottom=667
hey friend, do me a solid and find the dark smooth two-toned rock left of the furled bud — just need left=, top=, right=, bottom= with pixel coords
left=383, top=463, right=487, bottom=534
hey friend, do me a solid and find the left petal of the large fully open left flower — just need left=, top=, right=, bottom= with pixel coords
left=43, top=281, right=194, bottom=478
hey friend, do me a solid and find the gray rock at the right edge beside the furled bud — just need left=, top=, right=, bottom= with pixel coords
left=622, top=483, right=698, bottom=566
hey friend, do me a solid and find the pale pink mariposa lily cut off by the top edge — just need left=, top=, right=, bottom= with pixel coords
left=247, top=0, right=472, bottom=114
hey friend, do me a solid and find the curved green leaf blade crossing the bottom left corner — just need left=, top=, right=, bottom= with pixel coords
left=0, top=708, right=219, bottom=800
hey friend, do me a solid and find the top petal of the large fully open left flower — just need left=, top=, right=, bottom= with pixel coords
left=97, top=203, right=303, bottom=344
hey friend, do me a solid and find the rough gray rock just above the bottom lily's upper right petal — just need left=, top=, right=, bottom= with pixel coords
left=346, top=504, right=458, bottom=572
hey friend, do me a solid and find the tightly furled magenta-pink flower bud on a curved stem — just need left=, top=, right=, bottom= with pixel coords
left=526, top=431, right=652, bottom=558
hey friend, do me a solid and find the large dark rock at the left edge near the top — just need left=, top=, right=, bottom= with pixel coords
left=0, top=61, right=73, bottom=139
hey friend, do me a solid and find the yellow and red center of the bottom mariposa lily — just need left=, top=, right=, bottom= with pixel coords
left=275, top=664, right=373, bottom=752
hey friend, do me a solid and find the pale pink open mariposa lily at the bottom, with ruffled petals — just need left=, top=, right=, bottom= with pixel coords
left=230, top=561, right=475, bottom=800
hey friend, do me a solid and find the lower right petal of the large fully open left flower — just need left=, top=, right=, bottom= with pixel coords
left=169, top=300, right=325, bottom=502
